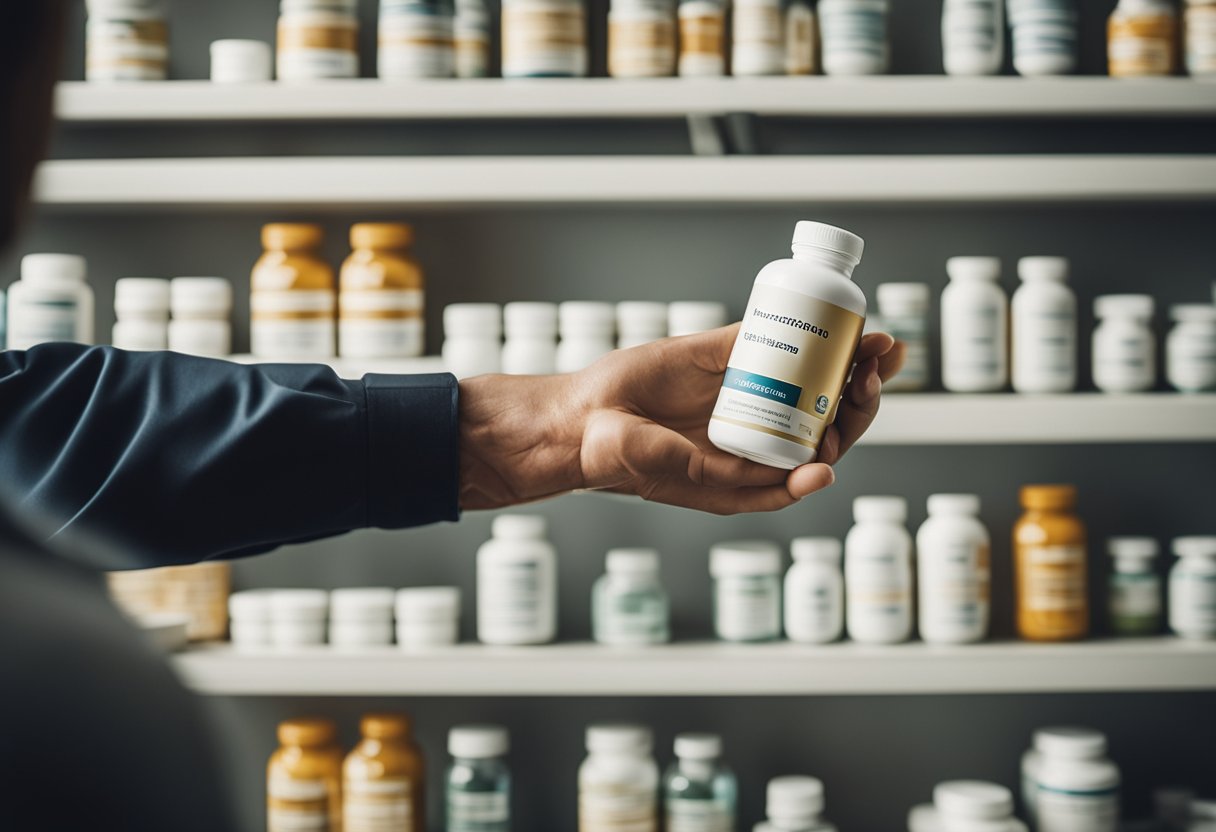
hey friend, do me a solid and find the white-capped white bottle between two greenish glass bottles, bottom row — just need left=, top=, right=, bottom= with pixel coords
left=579, top=725, right=659, bottom=832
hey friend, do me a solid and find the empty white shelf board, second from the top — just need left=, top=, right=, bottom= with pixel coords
left=28, top=154, right=1216, bottom=209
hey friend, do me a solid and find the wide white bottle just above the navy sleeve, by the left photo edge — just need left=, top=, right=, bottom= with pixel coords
left=9, top=254, right=94, bottom=349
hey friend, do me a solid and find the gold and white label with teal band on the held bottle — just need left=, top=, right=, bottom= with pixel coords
left=713, top=285, right=865, bottom=450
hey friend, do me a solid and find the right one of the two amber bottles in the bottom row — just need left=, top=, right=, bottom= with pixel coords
left=342, top=714, right=427, bottom=832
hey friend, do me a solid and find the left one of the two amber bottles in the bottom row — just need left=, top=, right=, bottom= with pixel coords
left=266, top=719, right=342, bottom=832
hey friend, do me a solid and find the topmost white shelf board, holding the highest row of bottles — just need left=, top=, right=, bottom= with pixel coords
left=57, top=75, right=1216, bottom=123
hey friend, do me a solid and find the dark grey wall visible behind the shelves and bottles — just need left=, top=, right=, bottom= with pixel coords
left=0, top=0, right=1216, bottom=832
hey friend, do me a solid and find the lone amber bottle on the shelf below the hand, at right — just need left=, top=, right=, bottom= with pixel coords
left=1013, top=485, right=1090, bottom=641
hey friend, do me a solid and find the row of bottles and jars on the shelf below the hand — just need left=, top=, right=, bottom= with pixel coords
left=111, top=485, right=1216, bottom=650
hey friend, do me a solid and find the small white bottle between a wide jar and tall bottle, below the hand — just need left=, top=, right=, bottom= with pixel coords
left=782, top=538, right=844, bottom=645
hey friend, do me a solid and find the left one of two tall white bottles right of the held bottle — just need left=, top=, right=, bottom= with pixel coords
left=941, top=257, right=1009, bottom=393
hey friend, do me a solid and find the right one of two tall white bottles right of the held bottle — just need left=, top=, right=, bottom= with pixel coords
left=1013, top=257, right=1076, bottom=393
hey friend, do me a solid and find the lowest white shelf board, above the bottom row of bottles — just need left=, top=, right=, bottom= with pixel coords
left=175, top=639, right=1216, bottom=697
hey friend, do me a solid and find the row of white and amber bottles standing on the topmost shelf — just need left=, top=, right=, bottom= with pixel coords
left=85, top=0, right=1216, bottom=83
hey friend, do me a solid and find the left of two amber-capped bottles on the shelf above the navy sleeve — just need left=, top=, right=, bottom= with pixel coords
left=249, top=223, right=337, bottom=361
